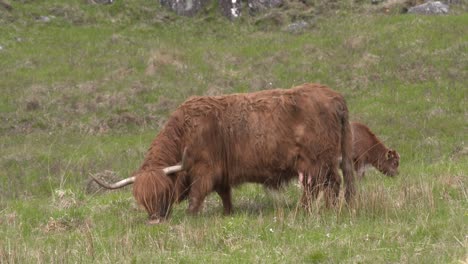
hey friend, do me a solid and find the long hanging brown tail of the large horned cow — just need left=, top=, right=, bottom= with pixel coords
left=340, top=101, right=356, bottom=203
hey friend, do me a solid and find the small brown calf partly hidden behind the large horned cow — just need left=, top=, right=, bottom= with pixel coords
left=351, top=122, right=400, bottom=178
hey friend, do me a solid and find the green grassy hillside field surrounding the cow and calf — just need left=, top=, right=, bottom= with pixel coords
left=0, top=0, right=468, bottom=263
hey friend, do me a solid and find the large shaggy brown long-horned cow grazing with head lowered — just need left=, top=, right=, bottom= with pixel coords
left=92, top=84, right=354, bottom=221
